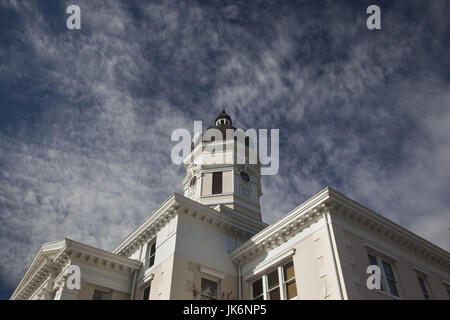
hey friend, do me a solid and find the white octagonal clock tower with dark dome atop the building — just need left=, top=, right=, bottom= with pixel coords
left=183, top=110, right=262, bottom=221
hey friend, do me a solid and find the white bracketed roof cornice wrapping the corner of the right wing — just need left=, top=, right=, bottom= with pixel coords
left=230, top=188, right=450, bottom=270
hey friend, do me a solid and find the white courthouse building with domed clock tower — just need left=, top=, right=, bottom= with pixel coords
left=11, top=111, right=450, bottom=300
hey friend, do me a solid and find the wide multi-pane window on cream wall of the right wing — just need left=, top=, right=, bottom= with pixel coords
left=252, top=262, right=298, bottom=300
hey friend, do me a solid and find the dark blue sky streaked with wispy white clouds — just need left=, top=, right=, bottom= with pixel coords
left=0, top=0, right=450, bottom=299
